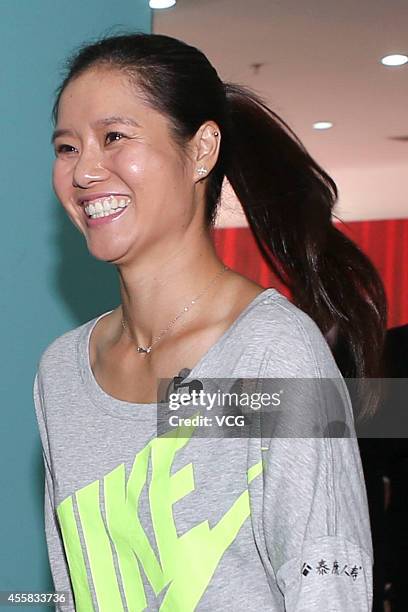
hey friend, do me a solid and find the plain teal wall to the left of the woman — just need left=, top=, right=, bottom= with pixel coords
left=0, top=0, right=151, bottom=612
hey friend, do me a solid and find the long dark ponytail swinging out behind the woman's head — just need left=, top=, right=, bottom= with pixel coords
left=225, top=83, right=387, bottom=418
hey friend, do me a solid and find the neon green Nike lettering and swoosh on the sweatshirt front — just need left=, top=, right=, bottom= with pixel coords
left=57, top=418, right=262, bottom=612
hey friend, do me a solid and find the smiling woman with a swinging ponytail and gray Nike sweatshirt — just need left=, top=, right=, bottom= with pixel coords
left=34, top=33, right=385, bottom=612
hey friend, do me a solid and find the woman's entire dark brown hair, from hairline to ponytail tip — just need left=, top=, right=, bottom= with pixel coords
left=53, top=32, right=386, bottom=416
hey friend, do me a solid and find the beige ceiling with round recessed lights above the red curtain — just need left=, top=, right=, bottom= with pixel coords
left=153, top=0, right=408, bottom=225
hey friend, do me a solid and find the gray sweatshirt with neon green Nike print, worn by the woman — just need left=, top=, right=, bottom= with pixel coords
left=34, top=288, right=373, bottom=612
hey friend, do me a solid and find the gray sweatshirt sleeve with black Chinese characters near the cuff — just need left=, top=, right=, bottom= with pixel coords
left=262, top=310, right=373, bottom=612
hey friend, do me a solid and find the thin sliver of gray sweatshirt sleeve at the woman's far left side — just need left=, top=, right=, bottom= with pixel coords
left=33, top=373, right=75, bottom=612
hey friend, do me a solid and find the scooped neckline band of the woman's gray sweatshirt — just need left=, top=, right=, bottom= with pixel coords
left=77, top=287, right=277, bottom=421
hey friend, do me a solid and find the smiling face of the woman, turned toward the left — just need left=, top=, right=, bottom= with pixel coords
left=53, top=69, right=202, bottom=263
